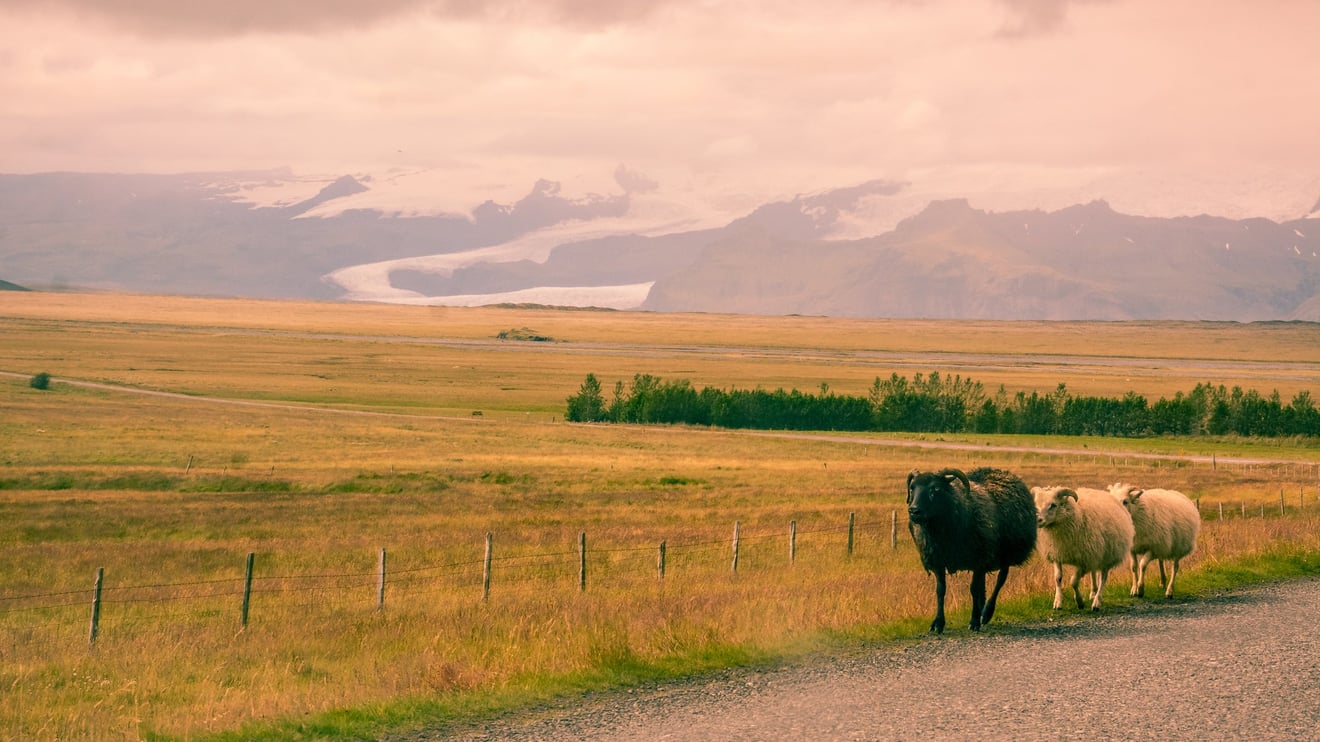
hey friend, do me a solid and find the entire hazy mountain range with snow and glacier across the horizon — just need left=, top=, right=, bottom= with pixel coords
left=0, top=168, right=1320, bottom=321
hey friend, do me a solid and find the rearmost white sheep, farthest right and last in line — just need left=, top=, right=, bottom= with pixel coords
left=1109, top=483, right=1201, bottom=598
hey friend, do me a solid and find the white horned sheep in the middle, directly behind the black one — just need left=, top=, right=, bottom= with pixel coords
left=1031, top=487, right=1133, bottom=611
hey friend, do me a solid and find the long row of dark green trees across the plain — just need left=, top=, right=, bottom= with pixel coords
left=565, top=371, right=1320, bottom=437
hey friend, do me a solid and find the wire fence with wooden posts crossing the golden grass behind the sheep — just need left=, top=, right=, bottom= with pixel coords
left=0, top=487, right=1315, bottom=646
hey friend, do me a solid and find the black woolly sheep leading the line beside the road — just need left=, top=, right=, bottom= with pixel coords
left=908, top=467, right=1036, bottom=634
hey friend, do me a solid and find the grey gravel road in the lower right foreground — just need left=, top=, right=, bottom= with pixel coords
left=419, top=578, right=1320, bottom=742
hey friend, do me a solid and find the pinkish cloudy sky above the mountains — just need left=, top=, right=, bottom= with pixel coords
left=0, top=0, right=1320, bottom=217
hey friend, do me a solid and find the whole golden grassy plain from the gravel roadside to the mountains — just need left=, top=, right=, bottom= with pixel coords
left=0, top=292, right=1320, bottom=739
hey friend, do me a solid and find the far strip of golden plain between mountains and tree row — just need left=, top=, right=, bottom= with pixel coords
left=0, top=292, right=1320, bottom=401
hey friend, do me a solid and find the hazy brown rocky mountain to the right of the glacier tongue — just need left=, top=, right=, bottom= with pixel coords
left=645, top=201, right=1320, bottom=321
